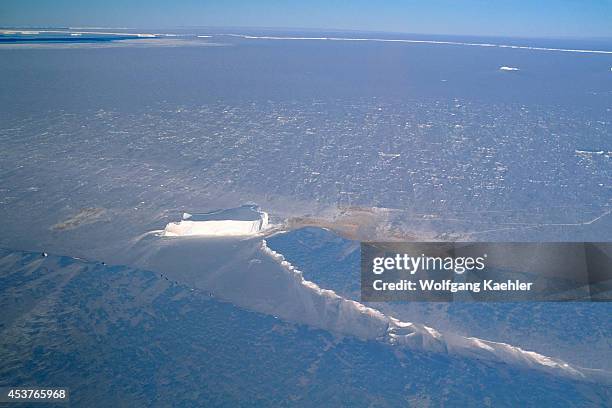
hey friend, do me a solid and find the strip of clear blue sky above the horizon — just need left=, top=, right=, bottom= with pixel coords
left=0, top=0, right=612, bottom=37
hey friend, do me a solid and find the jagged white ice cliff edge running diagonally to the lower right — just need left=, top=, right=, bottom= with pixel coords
left=261, top=240, right=609, bottom=382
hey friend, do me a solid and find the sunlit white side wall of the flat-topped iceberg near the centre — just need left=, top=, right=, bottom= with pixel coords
left=164, top=211, right=268, bottom=237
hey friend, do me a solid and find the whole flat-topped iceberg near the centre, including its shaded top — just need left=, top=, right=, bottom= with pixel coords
left=163, top=205, right=269, bottom=237
